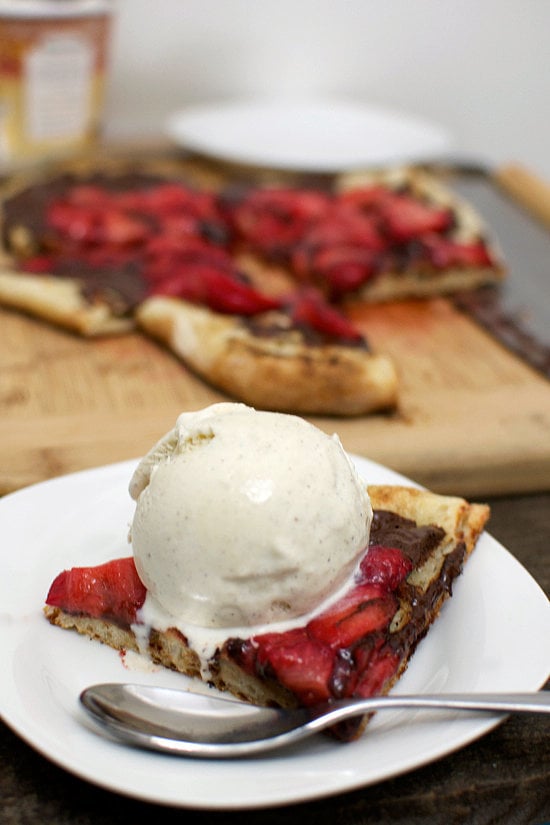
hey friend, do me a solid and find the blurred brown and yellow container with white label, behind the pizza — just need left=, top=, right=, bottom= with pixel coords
left=0, top=0, right=112, bottom=169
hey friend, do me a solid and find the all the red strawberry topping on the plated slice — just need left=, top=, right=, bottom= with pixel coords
left=46, top=532, right=418, bottom=716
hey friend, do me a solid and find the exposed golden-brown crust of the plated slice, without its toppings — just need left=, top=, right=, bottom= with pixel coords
left=45, top=485, right=489, bottom=734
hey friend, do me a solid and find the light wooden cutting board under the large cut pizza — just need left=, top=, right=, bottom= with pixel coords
left=0, top=288, right=550, bottom=497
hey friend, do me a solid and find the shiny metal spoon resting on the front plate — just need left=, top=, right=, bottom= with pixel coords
left=80, top=683, right=550, bottom=758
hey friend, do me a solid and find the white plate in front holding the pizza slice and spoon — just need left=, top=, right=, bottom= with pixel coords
left=0, top=458, right=550, bottom=809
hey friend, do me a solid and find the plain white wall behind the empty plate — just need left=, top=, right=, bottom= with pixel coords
left=102, top=0, right=550, bottom=181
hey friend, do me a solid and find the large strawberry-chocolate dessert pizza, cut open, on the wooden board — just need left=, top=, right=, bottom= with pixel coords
left=0, top=154, right=504, bottom=415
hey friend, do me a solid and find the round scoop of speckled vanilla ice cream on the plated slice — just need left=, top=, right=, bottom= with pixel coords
left=130, top=403, right=372, bottom=627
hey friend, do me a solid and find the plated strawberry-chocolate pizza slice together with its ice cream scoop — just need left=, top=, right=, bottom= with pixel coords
left=45, top=404, right=489, bottom=739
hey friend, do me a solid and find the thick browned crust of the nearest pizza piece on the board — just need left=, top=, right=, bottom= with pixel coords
left=136, top=297, right=397, bottom=416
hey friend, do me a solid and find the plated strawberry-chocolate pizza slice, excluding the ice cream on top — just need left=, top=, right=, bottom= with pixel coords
left=45, top=485, right=489, bottom=740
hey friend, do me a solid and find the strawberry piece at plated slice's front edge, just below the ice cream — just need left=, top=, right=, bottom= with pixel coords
left=254, top=628, right=333, bottom=705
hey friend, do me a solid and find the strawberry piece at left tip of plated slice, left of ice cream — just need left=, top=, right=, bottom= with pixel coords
left=46, top=556, right=147, bottom=627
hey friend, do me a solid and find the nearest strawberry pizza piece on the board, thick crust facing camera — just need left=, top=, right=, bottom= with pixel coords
left=136, top=289, right=399, bottom=416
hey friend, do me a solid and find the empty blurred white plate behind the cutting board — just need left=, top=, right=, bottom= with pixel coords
left=166, top=100, right=451, bottom=173
